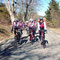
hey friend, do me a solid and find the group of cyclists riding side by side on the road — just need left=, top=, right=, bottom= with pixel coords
left=11, top=17, right=47, bottom=45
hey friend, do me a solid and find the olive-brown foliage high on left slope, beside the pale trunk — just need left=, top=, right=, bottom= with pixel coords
left=0, top=3, right=10, bottom=22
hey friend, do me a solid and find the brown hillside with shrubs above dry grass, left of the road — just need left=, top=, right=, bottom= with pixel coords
left=0, top=3, right=11, bottom=40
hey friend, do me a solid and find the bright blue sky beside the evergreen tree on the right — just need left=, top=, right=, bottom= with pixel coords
left=37, top=0, right=60, bottom=16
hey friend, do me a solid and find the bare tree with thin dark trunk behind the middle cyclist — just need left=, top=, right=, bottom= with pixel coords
left=19, top=0, right=40, bottom=20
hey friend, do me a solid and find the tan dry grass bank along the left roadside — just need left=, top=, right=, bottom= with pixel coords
left=0, top=24, right=13, bottom=43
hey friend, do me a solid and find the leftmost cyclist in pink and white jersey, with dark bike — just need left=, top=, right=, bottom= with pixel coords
left=11, top=18, right=23, bottom=44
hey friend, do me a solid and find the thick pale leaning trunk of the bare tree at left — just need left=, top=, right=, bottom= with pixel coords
left=5, top=0, right=16, bottom=23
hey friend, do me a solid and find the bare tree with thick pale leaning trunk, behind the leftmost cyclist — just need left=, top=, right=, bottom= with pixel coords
left=5, top=0, right=16, bottom=22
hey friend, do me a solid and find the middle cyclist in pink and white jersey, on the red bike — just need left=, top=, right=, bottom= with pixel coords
left=28, top=18, right=37, bottom=41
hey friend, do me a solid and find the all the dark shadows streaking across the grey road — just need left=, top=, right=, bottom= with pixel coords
left=0, top=33, right=60, bottom=60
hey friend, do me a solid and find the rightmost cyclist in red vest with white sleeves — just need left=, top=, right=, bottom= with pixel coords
left=38, top=17, right=47, bottom=40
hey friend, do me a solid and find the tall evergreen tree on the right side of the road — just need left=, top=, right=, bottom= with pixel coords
left=46, top=0, right=59, bottom=26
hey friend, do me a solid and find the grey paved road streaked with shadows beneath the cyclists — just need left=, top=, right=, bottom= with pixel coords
left=0, top=30, right=60, bottom=60
